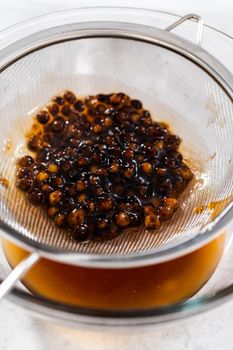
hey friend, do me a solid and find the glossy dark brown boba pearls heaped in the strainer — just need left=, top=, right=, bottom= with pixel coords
left=16, top=91, right=193, bottom=241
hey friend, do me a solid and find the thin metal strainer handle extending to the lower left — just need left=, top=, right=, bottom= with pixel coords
left=0, top=252, right=40, bottom=300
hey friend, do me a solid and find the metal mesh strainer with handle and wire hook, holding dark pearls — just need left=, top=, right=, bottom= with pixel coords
left=0, top=15, right=233, bottom=296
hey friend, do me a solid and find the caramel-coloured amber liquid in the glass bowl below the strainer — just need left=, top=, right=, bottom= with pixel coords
left=3, top=234, right=225, bottom=309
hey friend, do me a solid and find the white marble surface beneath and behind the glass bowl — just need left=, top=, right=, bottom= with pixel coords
left=0, top=0, right=233, bottom=350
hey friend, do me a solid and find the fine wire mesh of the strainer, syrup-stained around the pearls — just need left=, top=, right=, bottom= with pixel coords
left=0, top=30, right=233, bottom=266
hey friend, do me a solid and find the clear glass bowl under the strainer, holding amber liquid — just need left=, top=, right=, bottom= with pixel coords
left=0, top=7, right=233, bottom=325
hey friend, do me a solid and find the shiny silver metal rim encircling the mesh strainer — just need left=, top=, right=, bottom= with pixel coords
left=0, top=11, right=233, bottom=268
